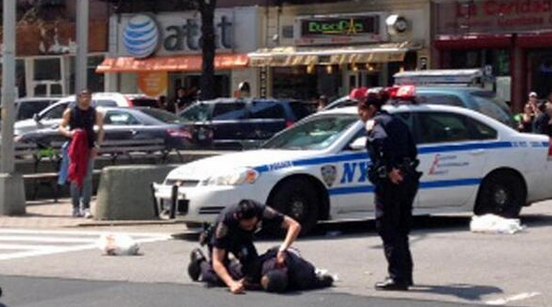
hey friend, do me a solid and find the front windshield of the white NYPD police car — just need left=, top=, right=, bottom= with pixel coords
left=262, top=114, right=358, bottom=150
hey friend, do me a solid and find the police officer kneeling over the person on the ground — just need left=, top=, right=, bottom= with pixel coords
left=188, top=199, right=301, bottom=294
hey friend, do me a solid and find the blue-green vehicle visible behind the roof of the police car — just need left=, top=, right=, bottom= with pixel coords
left=325, top=86, right=517, bottom=128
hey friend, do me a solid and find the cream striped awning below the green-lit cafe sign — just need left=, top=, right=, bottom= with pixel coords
left=248, top=42, right=421, bottom=66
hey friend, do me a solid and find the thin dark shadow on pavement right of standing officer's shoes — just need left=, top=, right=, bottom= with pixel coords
left=408, top=284, right=504, bottom=301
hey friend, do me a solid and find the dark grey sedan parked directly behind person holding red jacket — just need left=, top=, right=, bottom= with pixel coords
left=16, top=107, right=195, bottom=149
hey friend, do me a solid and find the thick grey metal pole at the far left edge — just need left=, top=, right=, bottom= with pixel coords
left=0, top=1, right=16, bottom=173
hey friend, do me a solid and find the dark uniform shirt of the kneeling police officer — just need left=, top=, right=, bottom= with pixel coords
left=211, top=203, right=284, bottom=251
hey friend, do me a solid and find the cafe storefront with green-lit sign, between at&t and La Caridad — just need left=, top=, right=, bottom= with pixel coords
left=249, top=0, right=431, bottom=99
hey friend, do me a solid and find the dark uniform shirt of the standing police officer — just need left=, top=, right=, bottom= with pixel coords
left=366, top=111, right=418, bottom=173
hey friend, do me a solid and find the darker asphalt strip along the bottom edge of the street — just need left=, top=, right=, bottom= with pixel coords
left=0, top=277, right=484, bottom=307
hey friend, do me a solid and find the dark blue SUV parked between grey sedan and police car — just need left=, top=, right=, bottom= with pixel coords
left=179, top=98, right=312, bottom=149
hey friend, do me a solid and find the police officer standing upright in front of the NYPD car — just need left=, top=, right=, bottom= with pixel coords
left=358, top=91, right=421, bottom=291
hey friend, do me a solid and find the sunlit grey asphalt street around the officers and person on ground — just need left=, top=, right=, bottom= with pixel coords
left=0, top=201, right=552, bottom=307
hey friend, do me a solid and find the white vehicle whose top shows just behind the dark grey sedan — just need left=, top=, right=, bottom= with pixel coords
left=14, top=93, right=158, bottom=136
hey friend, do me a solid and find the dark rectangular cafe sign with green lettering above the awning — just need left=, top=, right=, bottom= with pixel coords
left=295, top=14, right=383, bottom=45
